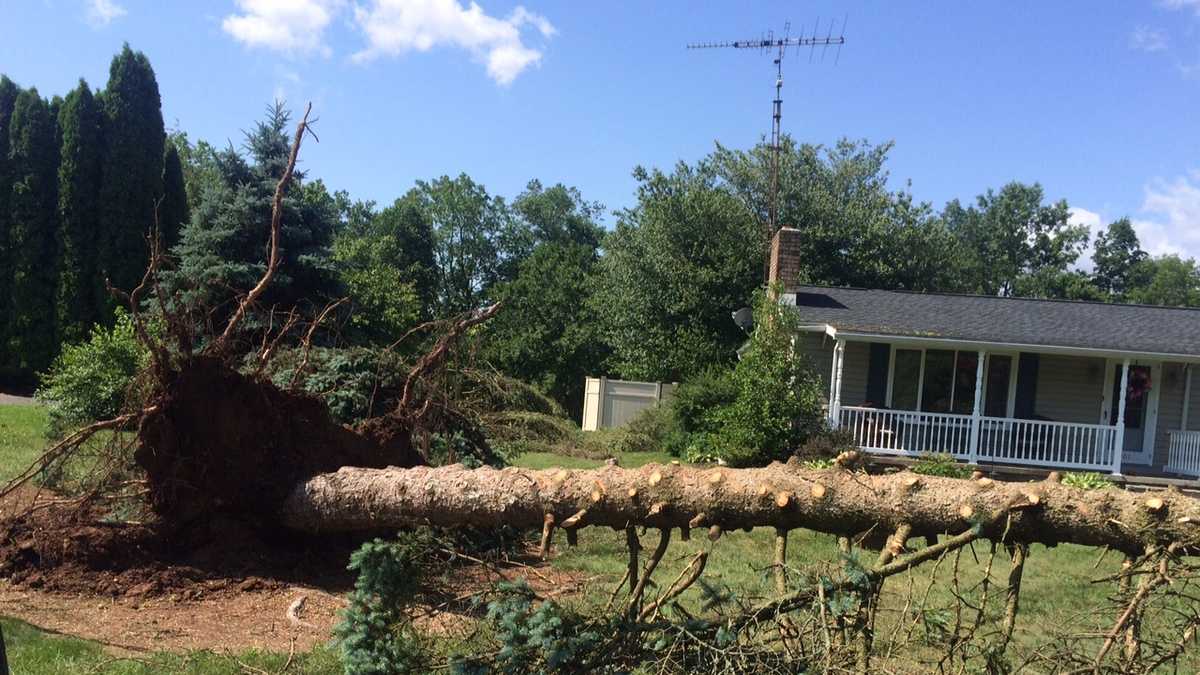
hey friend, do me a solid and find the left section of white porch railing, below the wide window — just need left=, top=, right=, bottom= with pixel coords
left=841, top=406, right=971, bottom=459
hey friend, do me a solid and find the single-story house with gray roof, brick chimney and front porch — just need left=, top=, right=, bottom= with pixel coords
left=770, top=228, right=1200, bottom=478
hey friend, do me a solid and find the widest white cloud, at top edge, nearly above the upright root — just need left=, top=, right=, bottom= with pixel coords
left=354, top=0, right=556, bottom=85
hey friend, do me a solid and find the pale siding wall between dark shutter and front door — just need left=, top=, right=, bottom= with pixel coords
left=1032, top=354, right=1105, bottom=424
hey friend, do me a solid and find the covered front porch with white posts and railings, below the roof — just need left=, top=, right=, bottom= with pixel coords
left=799, top=324, right=1200, bottom=478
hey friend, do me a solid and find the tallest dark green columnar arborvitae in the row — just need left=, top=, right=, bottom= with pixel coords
left=98, top=44, right=166, bottom=314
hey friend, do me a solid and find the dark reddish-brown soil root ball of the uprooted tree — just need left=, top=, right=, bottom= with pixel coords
left=134, top=357, right=424, bottom=524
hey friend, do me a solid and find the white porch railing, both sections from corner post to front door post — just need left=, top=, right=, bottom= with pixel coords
left=839, top=406, right=1118, bottom=472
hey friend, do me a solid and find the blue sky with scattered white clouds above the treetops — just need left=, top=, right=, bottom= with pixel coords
left=0, top=0, right=1200, bottom=261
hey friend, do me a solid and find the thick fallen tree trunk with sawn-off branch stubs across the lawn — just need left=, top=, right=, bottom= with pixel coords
left=280, top=462, right=1200, bottom=554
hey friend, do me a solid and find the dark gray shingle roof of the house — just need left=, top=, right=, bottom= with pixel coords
left=785, top=286, right=1200, bottom=356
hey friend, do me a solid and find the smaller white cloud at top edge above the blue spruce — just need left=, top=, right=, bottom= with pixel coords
left=221, top=0, right=343, bottom=56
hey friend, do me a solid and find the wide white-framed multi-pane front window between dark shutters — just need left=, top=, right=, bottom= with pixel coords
left=889, top=348, right=1013, bottom=417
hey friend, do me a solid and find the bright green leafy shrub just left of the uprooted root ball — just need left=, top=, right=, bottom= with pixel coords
left=36, top=309, right=148, bottom=438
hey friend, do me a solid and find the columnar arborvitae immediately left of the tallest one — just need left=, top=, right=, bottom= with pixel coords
left=55, top=79, right=104, bottom=342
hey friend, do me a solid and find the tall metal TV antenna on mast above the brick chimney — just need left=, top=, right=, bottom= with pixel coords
left=688, top=19, right=846, bottom=249
